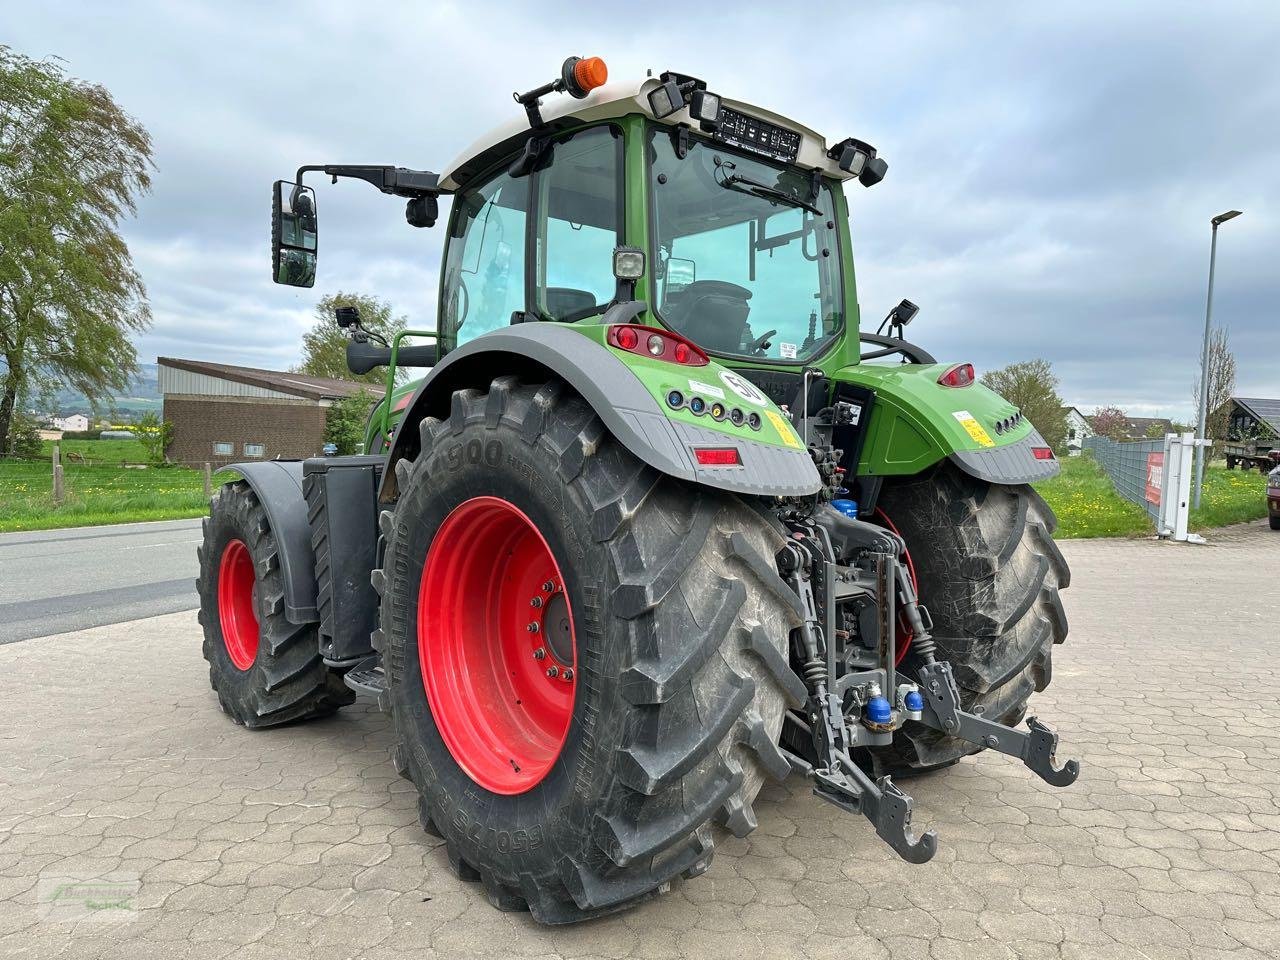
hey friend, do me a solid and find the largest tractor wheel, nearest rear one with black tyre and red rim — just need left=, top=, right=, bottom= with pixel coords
left=374, top=378, right=795, bottom=923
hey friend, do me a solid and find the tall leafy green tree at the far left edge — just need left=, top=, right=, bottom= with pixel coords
left=0, top=46, right=152, bottom=452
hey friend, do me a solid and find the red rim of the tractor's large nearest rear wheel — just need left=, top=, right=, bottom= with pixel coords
left=417, top=497, right=577, bottom=795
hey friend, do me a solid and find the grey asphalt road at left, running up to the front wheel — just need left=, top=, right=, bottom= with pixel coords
left=0, top=520, right=200, bottom=644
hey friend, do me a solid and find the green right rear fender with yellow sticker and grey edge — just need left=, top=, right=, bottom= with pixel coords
left=835, top=364, right=1059, bottom=484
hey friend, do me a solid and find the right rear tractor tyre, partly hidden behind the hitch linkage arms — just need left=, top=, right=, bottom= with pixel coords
left=870, top=463, right=1070, bottom=773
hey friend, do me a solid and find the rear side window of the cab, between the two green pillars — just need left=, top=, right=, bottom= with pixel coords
left=536, top=127, right=622, bottom=320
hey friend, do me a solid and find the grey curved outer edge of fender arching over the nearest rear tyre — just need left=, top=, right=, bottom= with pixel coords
left=379, top=323, right=820, bottom=502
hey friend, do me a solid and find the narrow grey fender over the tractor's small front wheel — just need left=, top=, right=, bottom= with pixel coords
left=227, top=460, right=319, bottom=623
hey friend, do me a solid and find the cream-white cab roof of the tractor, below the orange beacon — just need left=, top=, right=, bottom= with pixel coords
left=440, top=77, right=854, bottom=191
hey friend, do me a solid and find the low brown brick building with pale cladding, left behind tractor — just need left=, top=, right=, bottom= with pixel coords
left=157, top=357, right=383, bottom=467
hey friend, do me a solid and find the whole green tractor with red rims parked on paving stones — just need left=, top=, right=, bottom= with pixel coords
left=200, top=58, right=1079, bottom=923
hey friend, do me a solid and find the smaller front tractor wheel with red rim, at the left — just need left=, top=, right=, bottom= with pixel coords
left=196, top=480, right=356, bottom=727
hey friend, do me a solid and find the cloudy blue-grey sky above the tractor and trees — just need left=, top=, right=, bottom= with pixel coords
left=12, top=0, right=1280, bottom=417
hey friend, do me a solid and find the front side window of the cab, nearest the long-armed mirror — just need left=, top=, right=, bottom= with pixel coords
left=440, top=173, right=529, bottom=348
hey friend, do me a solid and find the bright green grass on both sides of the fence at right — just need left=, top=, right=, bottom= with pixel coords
left=1036, top=456, right=1267, bottom=539
